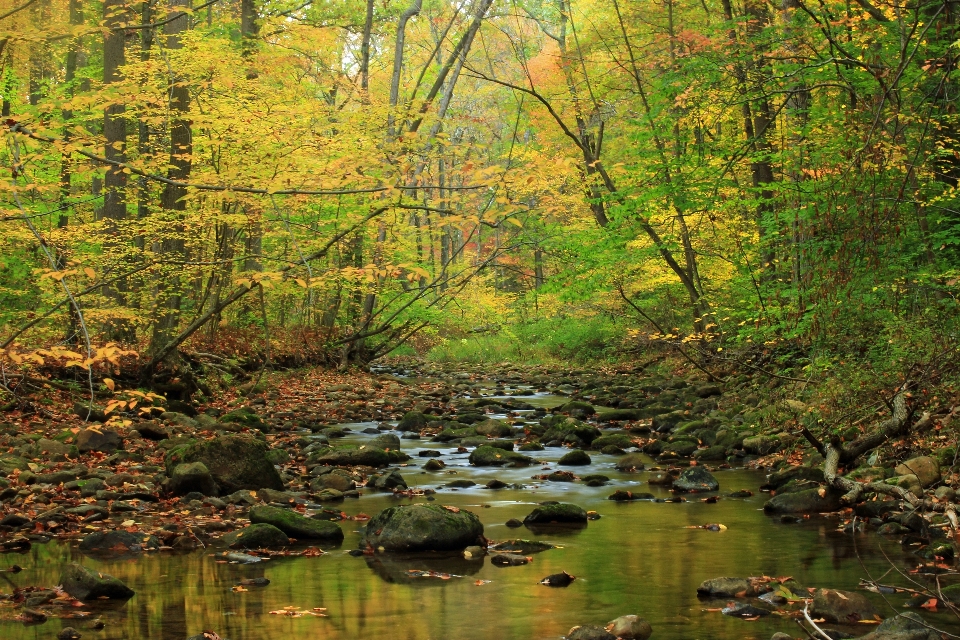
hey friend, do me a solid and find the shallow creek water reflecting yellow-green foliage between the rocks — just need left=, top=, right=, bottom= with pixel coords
left=0, top=395, right=957, bottom=640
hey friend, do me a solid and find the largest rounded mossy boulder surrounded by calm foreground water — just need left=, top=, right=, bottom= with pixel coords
left=365, top=504, right=483, bottom=551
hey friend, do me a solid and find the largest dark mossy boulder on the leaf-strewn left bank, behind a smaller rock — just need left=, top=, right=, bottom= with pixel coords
left=165, top=434, right=283, bottom=495
